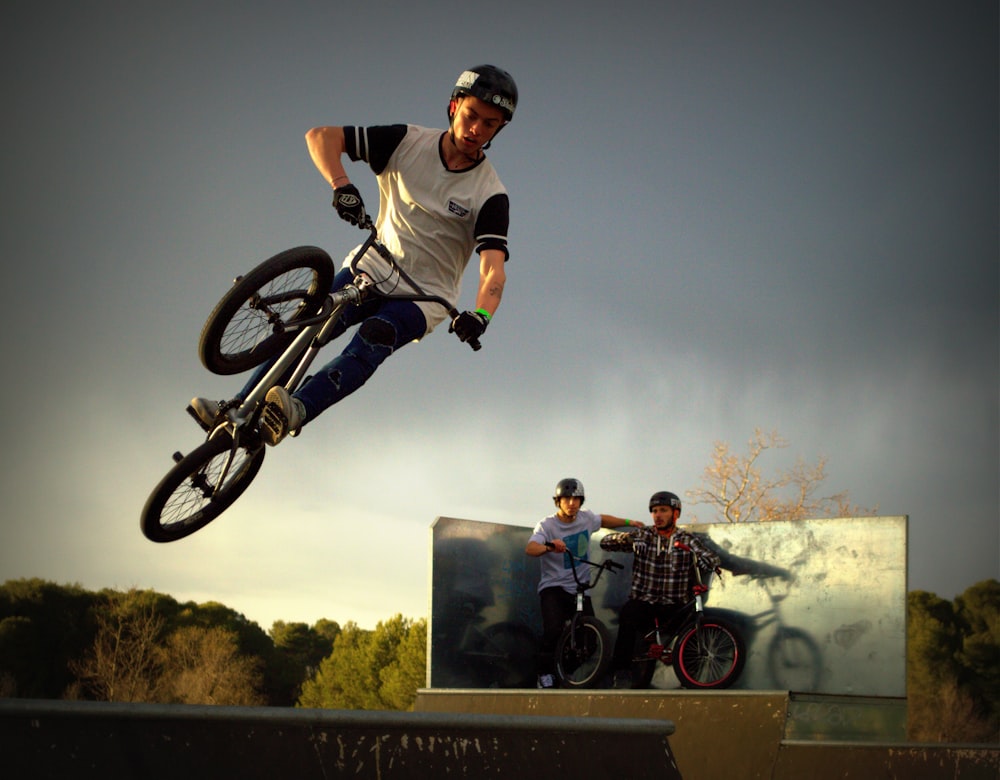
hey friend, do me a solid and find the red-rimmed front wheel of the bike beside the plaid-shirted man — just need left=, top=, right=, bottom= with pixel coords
left=673, top=618, right=746, bottom=689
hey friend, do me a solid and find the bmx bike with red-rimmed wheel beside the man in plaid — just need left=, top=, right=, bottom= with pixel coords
left=630, top=542, right=746, bottom=689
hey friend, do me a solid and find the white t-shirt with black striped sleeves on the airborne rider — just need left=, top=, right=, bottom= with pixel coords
left=344, top=125, right=510, bottom=333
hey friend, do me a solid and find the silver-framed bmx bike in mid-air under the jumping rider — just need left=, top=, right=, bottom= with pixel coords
left=140, top=219, right=481, bottom=542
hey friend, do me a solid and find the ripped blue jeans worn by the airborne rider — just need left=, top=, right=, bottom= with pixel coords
left=245, top=268, right=427, bottom=421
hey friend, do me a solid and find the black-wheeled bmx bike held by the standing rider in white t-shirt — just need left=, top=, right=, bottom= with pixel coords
left=555, top=552, right=625, bottom=688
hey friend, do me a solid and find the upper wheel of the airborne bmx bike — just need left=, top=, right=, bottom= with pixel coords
left=198, top=246, right=335, bottom=375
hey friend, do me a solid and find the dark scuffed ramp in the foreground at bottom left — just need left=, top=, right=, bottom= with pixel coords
left=0, top=699, right=680, bottom=780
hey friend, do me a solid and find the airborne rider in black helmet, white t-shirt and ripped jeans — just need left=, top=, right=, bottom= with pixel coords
left=191, top=65, right=518, bottom=446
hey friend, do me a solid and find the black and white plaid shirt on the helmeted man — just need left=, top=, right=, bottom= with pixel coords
left=601, top=526, right=720, bottom=604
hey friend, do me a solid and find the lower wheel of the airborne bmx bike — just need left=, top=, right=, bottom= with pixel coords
left=140, top=430, right=264, bottom=542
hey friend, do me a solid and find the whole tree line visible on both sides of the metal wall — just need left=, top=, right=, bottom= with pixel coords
left=0, top=579, right=1000, bottom=742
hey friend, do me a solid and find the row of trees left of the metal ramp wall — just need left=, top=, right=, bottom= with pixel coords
left=0, top=579, right=427, bottom=710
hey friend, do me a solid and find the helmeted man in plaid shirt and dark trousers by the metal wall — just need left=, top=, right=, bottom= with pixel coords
left=601, top=490, right=721, bottom=688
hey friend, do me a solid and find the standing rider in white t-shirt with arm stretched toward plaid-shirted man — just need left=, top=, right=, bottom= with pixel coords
left=524, top=478, right=642, bottom=688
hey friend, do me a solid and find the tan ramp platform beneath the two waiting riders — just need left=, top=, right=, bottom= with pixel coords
left=416, top=690, right=1000, bottom=780
